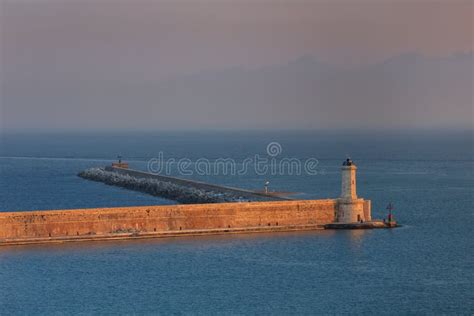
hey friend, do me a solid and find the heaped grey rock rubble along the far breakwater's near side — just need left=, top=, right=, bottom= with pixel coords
left=78, top=168, right=265, bottom=204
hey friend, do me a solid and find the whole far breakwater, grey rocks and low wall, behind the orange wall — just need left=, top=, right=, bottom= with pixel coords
left=78, top=168, right=281, bottom=204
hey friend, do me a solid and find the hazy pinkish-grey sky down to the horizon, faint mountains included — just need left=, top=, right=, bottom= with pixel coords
left=0, top=0, right=474, bottom=129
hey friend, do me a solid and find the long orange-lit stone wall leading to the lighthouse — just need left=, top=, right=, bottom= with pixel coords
left=0, top=200, right=337, bottom=246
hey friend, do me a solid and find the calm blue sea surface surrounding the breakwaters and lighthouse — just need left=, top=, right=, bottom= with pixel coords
left=0, top=132, right=474, bottom=315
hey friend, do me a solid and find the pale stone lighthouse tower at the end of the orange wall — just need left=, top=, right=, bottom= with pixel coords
left=336, top=158, right=371, bottom=223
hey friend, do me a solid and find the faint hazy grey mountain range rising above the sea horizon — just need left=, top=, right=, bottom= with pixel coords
left=148, top=54, right=474, bottom=128
